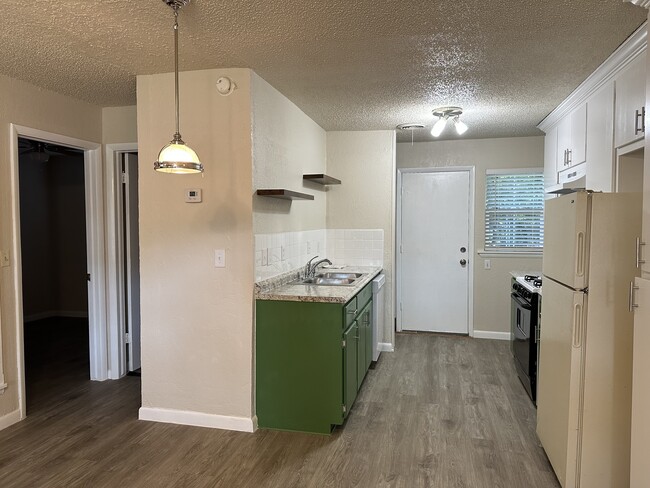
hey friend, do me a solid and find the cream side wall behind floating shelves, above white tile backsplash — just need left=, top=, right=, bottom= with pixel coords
left=251, top=73, right=327, bottom=234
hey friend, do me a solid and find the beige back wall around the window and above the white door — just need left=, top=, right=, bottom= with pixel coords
left=397, top=137, right=544, bottom=332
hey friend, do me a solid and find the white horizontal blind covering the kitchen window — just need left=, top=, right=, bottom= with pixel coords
left=485, top=169, right=544, bottom=251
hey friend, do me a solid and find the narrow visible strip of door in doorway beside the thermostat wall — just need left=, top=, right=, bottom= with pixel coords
left=123, top=153, right=140, bottom=371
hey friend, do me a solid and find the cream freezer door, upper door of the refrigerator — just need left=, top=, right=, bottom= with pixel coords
left=542, top=192, right=589, bottom=294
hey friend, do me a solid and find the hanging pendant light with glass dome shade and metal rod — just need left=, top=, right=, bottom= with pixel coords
left=153, top=0, right=203, bottom=174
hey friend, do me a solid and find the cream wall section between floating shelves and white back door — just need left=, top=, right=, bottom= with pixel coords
left=327, top=130, right=395, bottom=344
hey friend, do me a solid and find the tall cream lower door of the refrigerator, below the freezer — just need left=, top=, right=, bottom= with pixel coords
left=537, top=280, right=587, bottom=488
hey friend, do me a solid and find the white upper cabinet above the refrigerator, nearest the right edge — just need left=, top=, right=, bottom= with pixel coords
left=614, top=51, right=647, bottom=147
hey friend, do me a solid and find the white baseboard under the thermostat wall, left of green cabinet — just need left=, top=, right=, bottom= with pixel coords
left=139, top=407, right=257, bottom=432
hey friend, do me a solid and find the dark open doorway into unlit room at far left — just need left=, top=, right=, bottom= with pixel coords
left=18, top=137, right=90, bottom=411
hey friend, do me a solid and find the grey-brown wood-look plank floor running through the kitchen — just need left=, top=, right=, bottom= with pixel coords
left=0, top=334, right=559, bottom=488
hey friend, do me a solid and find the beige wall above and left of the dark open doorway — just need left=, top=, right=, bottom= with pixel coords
left=0, top=76, right=102, bottom=423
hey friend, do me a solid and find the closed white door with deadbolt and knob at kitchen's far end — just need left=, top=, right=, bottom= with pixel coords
left=398, top=170, right=470, bottom=334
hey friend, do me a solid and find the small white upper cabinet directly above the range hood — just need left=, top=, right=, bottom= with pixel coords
left=556, top=104, right=587, bottom=171
